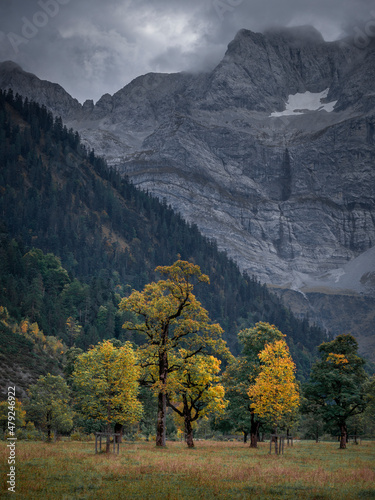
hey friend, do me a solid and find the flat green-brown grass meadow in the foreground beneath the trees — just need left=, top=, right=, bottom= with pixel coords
left=0, top=441, right=375, bottom=500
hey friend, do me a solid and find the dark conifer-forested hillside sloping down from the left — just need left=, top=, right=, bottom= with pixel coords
left=0, top=91, right=327, bottom=388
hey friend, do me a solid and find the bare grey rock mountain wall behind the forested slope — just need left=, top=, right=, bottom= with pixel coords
left=0, top=27, right=375, bottom=348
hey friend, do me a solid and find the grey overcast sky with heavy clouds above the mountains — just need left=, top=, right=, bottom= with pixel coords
left=0, top=0, right=375, bottom=102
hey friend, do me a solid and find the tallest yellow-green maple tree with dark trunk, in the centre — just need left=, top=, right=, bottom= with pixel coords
left=120, top=260, right=228, bottom=446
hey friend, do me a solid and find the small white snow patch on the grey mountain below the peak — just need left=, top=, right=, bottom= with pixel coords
left=270, top=88, right=337, bottom=117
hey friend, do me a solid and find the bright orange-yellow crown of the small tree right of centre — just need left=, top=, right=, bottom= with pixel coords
left=248, top=339, right=300, bottom=431
